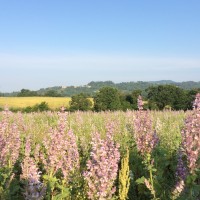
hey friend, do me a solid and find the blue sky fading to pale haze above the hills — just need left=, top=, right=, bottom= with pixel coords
left=0, top=0, right=200, bottom=92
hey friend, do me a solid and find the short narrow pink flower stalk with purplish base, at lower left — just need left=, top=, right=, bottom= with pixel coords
left=20, top=138, right=46, bottom=200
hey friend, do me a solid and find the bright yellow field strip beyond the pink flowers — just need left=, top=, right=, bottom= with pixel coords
left=0, top=97, right=71, bottom=109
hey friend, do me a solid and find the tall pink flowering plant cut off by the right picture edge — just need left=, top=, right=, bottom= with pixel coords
left=173, top=93, right=200, bottom=200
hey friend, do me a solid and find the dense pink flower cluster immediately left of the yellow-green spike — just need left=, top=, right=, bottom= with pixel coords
left=84, top=129, right=120, bottom=200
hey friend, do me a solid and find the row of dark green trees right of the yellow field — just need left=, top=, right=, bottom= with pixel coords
left=70, top=85, right=200, bottom=112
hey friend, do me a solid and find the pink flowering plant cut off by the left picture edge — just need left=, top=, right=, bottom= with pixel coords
left=0, top=108, right=21, bottom=199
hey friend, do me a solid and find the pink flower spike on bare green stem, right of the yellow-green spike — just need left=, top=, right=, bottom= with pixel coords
left=134, top=96, right=159, bottom=199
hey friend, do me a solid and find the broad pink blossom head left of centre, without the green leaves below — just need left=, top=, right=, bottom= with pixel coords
left=41, top=112, right=80, bottom=181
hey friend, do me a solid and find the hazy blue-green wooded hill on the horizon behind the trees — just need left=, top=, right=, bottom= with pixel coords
left=1, top=80, right=200, bottom=97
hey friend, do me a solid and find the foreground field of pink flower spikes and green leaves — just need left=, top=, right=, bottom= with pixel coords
left=0, top=94, right=200, bottom=200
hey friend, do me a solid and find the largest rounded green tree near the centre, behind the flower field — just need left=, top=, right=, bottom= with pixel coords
left=94, top=87, right=121, bottom=111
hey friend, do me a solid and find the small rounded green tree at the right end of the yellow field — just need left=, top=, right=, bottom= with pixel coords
left=70, top=93, right=92, bottom=111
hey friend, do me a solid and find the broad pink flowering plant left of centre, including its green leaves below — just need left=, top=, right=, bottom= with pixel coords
left=40, top=108, right=80, bottom=199
